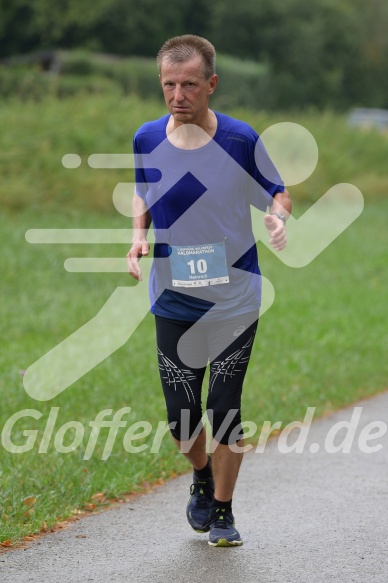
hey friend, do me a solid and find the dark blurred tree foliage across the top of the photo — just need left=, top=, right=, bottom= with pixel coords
left=0, top=0, right=388, bottom=108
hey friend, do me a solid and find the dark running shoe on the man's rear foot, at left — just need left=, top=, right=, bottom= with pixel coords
left=186, top=476, right=214, bottom=532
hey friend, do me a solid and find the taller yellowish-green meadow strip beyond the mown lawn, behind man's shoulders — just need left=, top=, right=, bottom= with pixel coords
left=0, top=94, right=388, bottom=214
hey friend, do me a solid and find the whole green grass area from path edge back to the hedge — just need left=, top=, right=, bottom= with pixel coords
left=0, top=97, right=388, bottom=541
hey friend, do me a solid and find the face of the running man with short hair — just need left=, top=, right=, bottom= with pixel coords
left=160, top=57, right=218, bottom=125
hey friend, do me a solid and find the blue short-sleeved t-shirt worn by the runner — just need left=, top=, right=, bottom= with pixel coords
left=133, top=112, right=284, bottom=321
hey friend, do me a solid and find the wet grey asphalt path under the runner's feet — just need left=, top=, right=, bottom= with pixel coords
left=0, top=392, right=388, bottom=583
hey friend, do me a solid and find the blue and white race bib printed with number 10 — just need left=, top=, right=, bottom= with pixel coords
left=170, top=242, right=229, bottom=287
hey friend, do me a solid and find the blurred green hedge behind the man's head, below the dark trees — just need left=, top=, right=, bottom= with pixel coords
left=0, top=51, right=271, bottom=110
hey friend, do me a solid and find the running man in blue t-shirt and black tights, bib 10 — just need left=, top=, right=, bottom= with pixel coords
left=127, top=35, right=292, bottom=547
